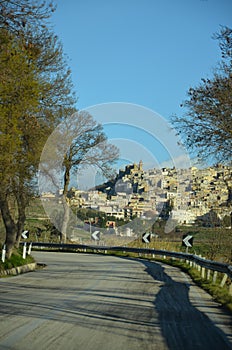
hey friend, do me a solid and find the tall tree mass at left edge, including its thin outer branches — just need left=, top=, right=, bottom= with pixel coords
left=0, top=0, right=75, bottom=257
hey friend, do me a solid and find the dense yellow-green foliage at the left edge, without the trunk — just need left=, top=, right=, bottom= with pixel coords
left=0, top=30, right=39, bottom=182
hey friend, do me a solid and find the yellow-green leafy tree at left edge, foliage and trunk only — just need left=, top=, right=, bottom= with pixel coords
left=0, top=30, right=39, bottom=254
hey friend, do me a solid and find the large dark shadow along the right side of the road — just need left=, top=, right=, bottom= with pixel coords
left=141, top=261, right=232, bottom=350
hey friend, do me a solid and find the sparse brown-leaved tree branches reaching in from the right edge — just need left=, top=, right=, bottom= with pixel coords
left=172, top=27, right=232, bottom=164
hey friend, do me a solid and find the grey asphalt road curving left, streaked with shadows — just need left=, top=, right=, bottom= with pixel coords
left=0, top=252, right=232, bottom=350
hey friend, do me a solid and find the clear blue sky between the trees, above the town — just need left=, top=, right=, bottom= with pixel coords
left=51, top=0, right=232, bottom=175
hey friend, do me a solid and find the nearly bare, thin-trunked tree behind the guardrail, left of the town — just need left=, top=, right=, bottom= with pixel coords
left=40, top=111, right=118, bottom=242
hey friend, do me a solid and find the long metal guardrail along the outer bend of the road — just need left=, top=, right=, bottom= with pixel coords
left=32, top=242, right=232, bottom=279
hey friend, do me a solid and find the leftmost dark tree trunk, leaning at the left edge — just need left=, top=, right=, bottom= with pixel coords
left=0, top=195, right=17, bottom=259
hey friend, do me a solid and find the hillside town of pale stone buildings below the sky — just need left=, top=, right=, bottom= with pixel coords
left=60, top=161, right=232, bottom=225
